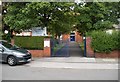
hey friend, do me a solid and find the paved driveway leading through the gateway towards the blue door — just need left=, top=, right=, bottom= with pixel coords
left=55, top=42, right=83, bottom=57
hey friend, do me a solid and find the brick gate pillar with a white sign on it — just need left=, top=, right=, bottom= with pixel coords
left=44, top=38, right=51, bottom=57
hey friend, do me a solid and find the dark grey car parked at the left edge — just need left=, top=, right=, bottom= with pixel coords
left=0, top=40, right=32, bottom=66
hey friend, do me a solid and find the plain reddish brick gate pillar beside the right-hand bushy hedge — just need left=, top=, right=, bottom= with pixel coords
left=86, top=37, right=94, bottom=57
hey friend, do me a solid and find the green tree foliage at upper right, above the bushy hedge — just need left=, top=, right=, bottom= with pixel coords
left=75, top=2, right=120, bottom=34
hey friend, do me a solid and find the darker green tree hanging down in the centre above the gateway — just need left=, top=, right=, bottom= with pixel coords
left=50, top=3, right=75, bottom=38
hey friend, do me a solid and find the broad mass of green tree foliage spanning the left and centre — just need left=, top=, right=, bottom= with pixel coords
left=4, top=2, right=74, bottom=41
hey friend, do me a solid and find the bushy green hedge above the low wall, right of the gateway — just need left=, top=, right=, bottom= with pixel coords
left=91, top=31, right=120, bottom=53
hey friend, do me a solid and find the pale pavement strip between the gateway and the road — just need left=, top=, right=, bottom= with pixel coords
left=25, top=57, right=118, bottom=69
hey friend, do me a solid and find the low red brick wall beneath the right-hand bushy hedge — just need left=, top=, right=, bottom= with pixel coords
left=95, top=50, right=120, bottom=58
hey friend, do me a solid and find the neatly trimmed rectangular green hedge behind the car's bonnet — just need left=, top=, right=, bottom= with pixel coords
left=14, top=36, right=44, bottom=50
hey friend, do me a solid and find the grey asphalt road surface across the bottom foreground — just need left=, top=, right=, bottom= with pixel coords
left=2, top=64, right=118, bottom=80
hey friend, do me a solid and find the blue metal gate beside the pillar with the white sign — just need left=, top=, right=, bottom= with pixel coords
left=51, top=39, right=69, bottom=57
